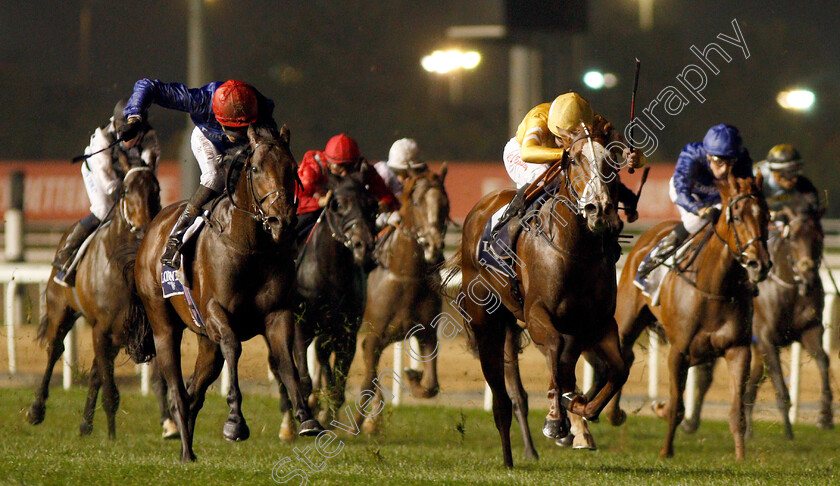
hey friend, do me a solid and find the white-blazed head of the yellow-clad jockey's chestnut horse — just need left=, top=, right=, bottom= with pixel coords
left=559, top=117, right=622, bottom=233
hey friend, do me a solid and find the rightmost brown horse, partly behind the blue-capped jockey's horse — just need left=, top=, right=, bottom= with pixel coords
left=683, top=203, right=833, bottom=439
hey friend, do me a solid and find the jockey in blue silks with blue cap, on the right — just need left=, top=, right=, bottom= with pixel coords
left=635, top=123, right=752, bottom=290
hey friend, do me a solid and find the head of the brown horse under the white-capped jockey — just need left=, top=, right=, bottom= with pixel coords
left=400, top=163, right=449, bottom=265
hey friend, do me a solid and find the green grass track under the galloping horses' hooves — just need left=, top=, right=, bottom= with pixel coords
left=0, top=387, right=840, bottom=486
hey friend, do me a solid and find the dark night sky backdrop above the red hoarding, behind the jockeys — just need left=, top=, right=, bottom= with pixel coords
left=0, top=0, right=840, bottom=209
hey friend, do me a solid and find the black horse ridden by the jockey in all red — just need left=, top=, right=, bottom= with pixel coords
left=278, top=170, right=377, bottom=439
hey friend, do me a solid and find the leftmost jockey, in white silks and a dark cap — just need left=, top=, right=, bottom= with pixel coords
left=53, top=100, right=160, bottom=287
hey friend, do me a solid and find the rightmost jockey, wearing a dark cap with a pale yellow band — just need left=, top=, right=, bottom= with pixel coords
left=755, top=144, right=819, bottom=212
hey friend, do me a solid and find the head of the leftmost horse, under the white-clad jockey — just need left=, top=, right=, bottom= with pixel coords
left=119, top=165, right=160, bottom=237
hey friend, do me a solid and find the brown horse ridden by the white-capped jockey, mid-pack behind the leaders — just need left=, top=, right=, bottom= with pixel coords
left=357, top=164, right=449, bottom=432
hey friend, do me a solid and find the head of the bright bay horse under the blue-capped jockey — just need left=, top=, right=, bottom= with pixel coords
left=716, top=174, right=771, bottom=284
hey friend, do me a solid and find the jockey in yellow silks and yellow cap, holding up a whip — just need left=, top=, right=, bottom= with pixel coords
left=493, top=92, right=645, bottom=238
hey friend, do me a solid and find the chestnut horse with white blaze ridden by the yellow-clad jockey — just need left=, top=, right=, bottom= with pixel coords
left=447, top=118, right=627, bottom=467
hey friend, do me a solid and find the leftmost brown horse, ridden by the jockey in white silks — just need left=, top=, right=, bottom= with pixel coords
left=26, top=162, right=160, bottom=439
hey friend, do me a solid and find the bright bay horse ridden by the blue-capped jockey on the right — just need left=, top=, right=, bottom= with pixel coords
left=607, top=176, right=770, bottom=460
